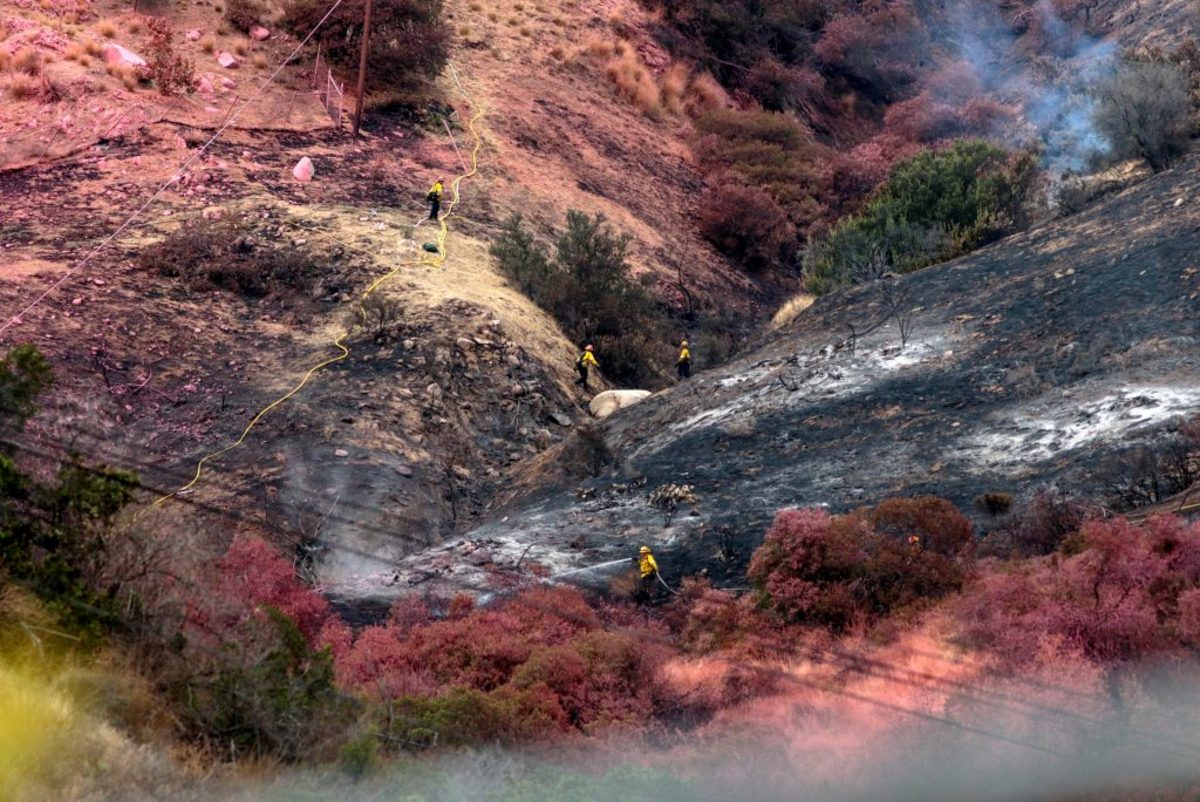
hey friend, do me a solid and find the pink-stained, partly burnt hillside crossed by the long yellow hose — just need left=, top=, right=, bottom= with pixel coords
left=0, top=2, right=757, bottom=591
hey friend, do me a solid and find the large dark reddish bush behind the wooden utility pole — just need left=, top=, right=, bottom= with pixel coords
left=282, top=0, right=450, bottom=91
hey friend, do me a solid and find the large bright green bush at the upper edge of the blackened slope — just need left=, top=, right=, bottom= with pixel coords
left=804, top=139, right=1037, bottom=294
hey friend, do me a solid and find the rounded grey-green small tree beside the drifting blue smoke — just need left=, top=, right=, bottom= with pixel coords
left=1096, top=61, right=1192, bottom=173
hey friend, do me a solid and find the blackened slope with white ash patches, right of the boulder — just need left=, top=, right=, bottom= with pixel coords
left=362, top=156, right=1200, bottom=594
